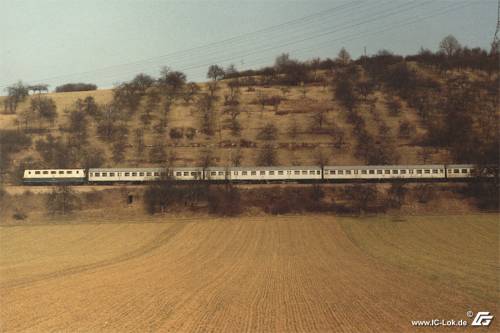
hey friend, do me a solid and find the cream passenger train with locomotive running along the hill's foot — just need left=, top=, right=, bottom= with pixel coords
left=23, top=164, right=486, bottom=185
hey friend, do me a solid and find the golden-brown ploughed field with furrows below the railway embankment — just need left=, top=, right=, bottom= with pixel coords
left=0, top=214, right=499, bottom=332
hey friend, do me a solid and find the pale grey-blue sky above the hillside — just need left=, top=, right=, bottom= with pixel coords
left=0, top=0, right=497, bottom=93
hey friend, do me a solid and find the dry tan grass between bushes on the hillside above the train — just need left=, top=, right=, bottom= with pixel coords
left=0, top=71, right=447, bottom=166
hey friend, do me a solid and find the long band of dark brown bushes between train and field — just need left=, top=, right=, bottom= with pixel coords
left=143, top=181, right=499, bottom=216
